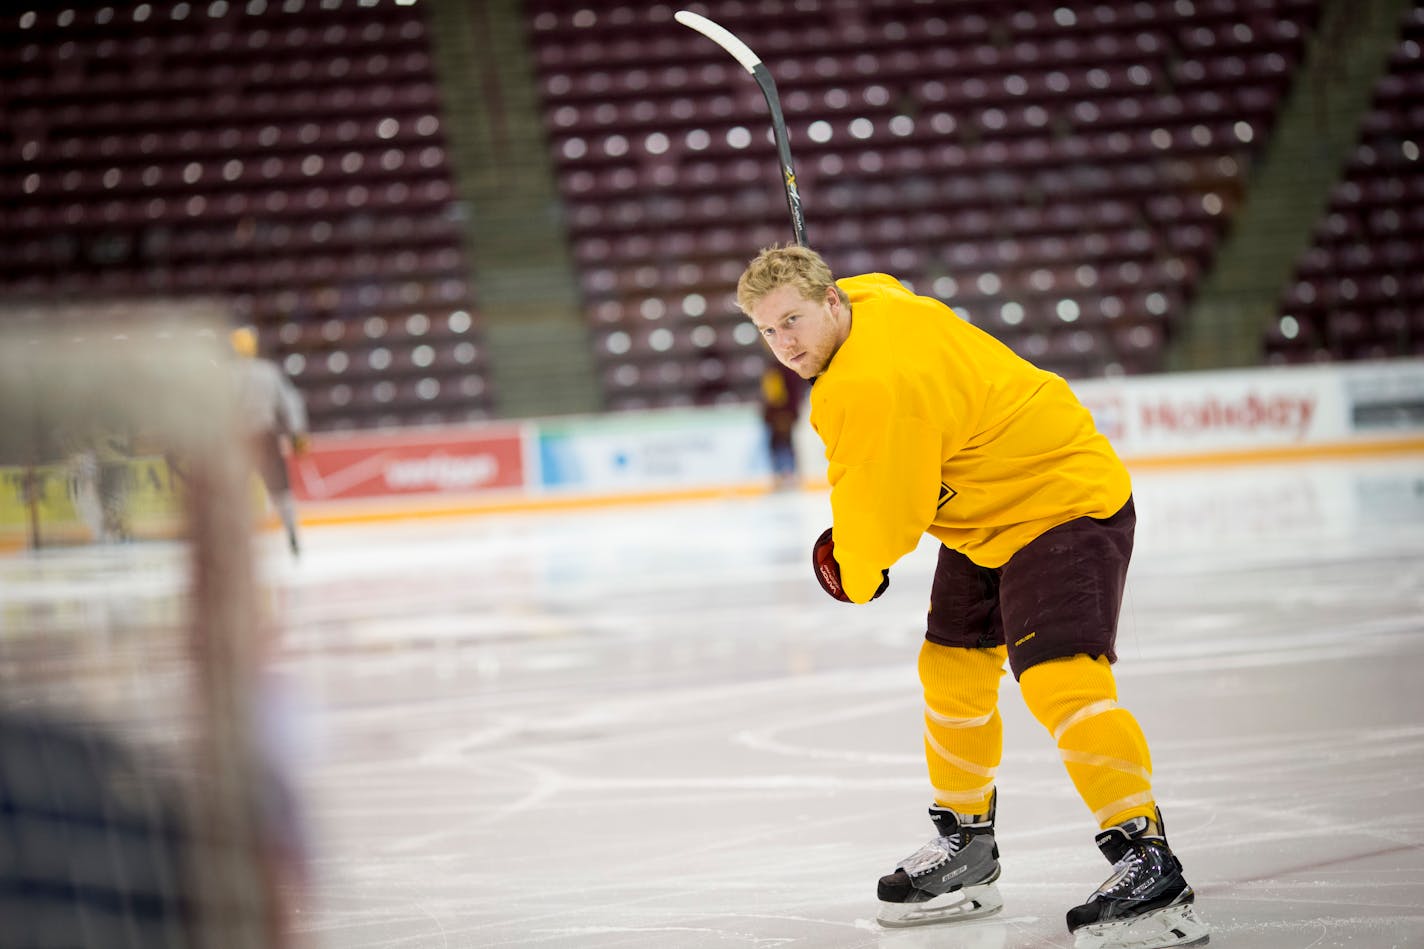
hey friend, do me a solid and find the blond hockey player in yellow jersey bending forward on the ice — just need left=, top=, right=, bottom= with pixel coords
left=738, top=247, right=1209, bottom=949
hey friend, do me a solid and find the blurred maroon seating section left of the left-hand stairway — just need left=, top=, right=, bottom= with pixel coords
left=0, top=0, right=491, bottom=429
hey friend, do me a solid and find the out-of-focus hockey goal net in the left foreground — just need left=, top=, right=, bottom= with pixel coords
left=0, top=304, right=299, bottom=949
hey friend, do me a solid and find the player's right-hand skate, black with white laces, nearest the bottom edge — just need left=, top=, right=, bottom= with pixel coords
left=1068, top=811, right=1212, bottom=949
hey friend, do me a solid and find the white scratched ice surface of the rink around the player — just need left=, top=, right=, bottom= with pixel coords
left=7, top=456, right=1424, bottom=949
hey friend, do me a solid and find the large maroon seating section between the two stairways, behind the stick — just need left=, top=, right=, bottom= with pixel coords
left=527, top=0, right=1317, bottom=408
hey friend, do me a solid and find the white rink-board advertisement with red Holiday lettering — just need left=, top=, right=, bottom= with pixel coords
left=1075, top=369, right=1351, bottom=456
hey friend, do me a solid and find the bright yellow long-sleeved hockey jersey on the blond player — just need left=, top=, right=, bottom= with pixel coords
left=810, top=274, right=1132, bottom=603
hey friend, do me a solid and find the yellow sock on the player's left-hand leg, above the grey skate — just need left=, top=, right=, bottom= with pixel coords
left=920, top=640, right=1008, bottom=814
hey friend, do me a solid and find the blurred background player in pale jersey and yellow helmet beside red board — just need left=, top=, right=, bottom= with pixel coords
left=232, top=326, right=310, bottom=554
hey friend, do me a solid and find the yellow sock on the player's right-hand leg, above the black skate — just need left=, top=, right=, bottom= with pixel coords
left=1018, top=655, right=1156, bottom=829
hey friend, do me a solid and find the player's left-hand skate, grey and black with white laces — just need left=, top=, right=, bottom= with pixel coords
left=877, top=798, right=1004, bottom=926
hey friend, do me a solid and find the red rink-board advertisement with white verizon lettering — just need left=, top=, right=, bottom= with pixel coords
left=289, top=426, right=525, bottom=502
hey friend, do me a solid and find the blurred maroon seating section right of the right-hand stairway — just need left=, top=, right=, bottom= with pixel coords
left=1266, top=6, right=1424, bottom=362
